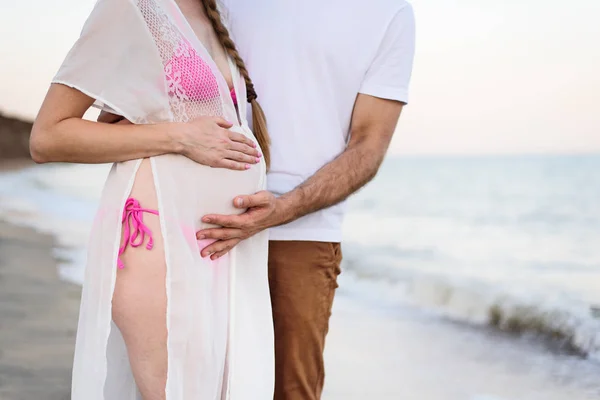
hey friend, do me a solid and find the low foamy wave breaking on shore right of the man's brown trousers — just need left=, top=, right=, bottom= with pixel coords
left=340, top=262, right=600, bottom=362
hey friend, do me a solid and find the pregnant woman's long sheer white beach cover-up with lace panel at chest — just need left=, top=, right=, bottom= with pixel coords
left=53, top=0, right=274, bottom=400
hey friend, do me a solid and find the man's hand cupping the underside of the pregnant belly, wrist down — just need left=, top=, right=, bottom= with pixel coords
left=196, top=191, right=285, bottom=260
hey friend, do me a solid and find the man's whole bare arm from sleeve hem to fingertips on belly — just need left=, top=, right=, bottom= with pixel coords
left=196, top=94, right=403, bottom=260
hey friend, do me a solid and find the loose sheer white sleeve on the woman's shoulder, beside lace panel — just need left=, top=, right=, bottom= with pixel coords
left=52, top=0, right=172, bottom=123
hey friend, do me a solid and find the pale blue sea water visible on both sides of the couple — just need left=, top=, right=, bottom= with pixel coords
left=0, top=155, right=600, bottom=398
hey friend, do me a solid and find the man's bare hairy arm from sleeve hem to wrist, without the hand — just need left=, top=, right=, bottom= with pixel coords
left=277, top=94, right=404, bottom=224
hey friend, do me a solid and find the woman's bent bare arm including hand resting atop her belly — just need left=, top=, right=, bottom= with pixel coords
left=30, top=84, right=260, bottom=170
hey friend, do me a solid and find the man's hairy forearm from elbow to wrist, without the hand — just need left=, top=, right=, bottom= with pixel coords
left=277, top=141, right=387, bottom=224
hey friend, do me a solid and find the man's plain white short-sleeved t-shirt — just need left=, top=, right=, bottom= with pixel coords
left=223, top=0, right=415, bottom=242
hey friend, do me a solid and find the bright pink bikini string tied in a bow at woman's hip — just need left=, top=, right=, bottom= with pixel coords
left=117, top=197, right=158, bottom=269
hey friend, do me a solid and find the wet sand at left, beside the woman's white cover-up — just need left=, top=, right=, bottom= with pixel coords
left=0, top=221, right=80, bottom=400
